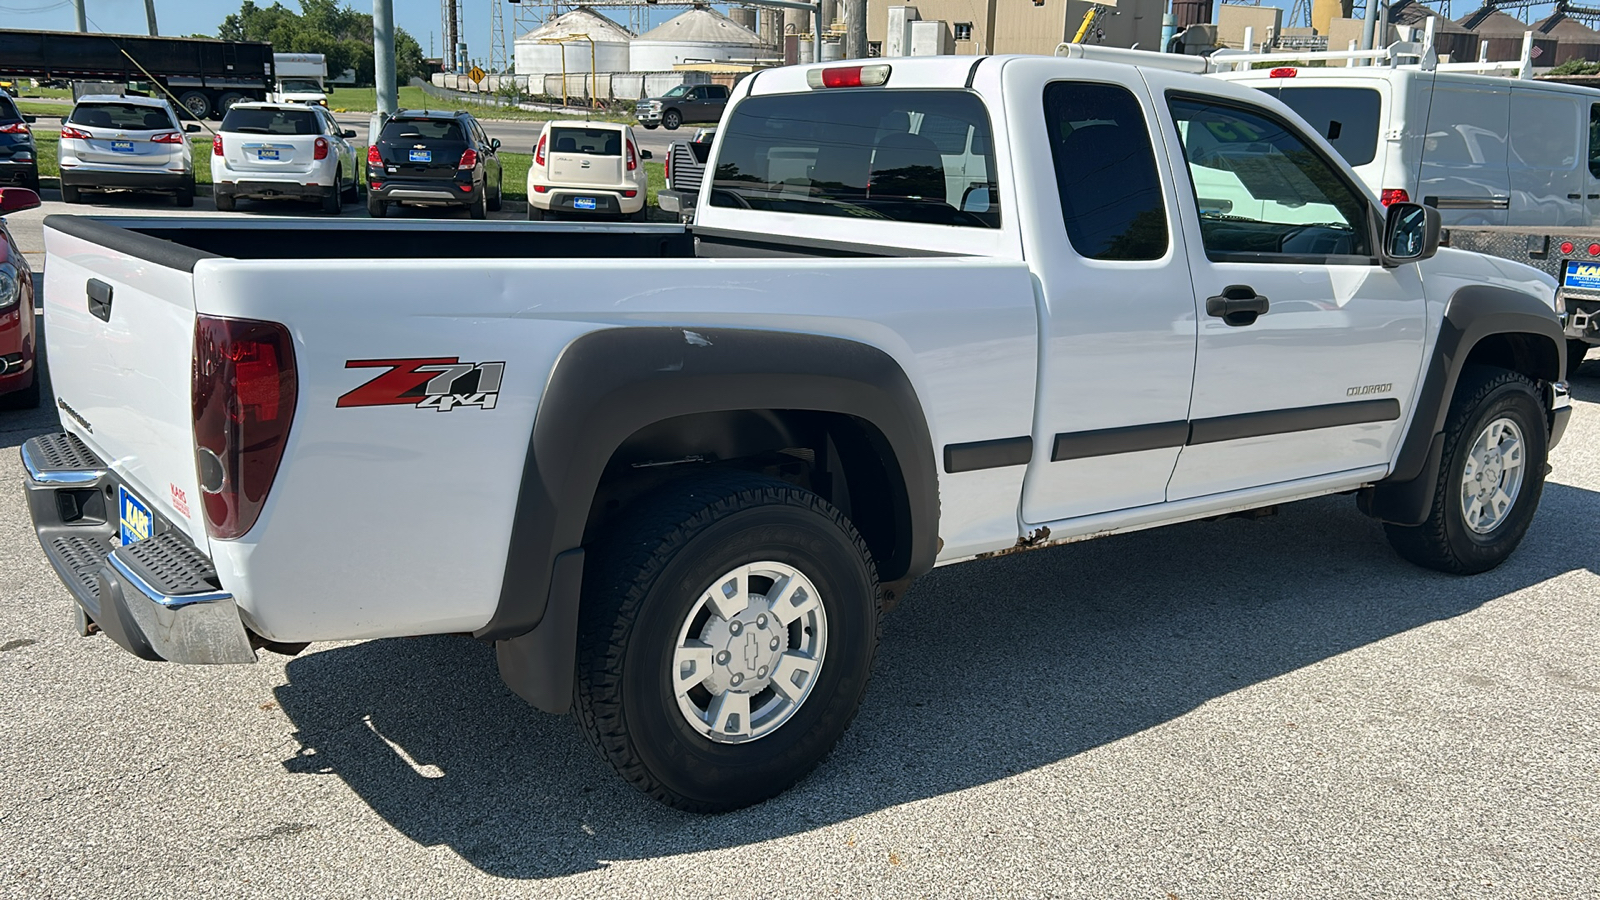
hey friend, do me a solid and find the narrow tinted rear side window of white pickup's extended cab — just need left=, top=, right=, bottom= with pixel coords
left=1045, top=82, right=1168, bottom=259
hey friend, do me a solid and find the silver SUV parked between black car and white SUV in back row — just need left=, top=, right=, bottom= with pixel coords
left=58, top=94, right=200, bottom=207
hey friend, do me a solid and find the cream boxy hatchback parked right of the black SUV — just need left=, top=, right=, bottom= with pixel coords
left=528, top=122, right=651, bottom=221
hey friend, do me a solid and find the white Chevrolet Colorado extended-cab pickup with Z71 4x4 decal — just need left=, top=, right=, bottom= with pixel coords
left=22, top=54, right=1570, bottom=810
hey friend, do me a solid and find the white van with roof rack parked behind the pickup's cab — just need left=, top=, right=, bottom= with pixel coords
left=1214, top=62, right=1600, bottom=226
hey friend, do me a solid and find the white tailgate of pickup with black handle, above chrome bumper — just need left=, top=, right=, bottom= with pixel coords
left=45, top=216, right=208, bottom=551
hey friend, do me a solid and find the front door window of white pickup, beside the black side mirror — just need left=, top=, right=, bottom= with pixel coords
left=1170, top=96, right=1371, bottom=266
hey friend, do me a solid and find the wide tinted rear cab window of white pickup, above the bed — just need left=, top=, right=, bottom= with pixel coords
left=710, top=90, right=1000, bottom=229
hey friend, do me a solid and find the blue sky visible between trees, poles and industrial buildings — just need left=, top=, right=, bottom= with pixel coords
left=0, top=0, right=1574, bottom=59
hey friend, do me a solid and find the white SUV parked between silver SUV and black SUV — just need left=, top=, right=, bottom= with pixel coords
left=211, top=102, right=360, bottom=216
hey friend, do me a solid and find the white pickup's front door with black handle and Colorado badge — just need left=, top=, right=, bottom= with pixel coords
left=1163, top=82, right=1424, bottom=500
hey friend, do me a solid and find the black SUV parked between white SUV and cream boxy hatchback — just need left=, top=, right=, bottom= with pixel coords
left=366, top=109, right=501, bottom=219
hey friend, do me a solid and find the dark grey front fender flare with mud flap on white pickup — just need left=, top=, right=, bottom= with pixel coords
left=1363, top=285, right=1566, bottom=525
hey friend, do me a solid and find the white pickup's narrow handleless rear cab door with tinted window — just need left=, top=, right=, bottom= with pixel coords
left=1005, top=59, right=1195, bottom=524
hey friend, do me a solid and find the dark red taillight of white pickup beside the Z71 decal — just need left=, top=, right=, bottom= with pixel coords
left=190, top=315, right=299, bottom=540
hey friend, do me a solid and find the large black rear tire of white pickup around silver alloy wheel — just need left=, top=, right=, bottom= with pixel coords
left=573, top=471, right=882, bottom=812
